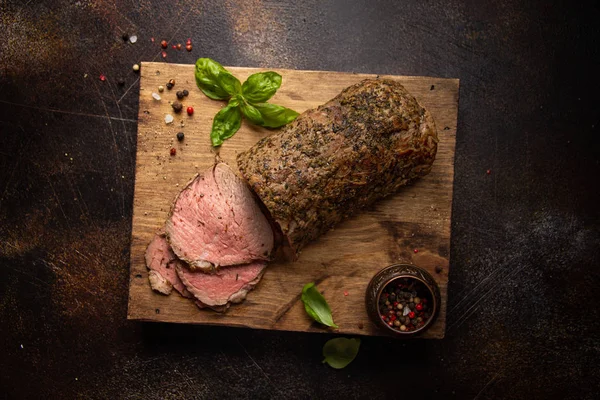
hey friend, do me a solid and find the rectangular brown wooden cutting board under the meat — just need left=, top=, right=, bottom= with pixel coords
left=128, top=62, right=459, bottom=338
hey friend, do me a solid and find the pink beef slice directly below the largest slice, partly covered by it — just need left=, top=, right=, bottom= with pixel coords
left=176, top=261, right=267, bottom=311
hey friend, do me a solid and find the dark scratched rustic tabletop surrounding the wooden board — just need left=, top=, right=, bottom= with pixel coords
left=0, top=0, right=600, bottom=399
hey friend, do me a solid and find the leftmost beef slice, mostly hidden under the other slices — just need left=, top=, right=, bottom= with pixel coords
left=146, top=233, right=192, bottom=297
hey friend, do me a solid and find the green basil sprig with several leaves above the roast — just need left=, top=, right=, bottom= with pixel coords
left=194, top=58, right=298, bottom=146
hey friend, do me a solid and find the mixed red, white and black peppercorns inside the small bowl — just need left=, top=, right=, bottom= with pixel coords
left=379, top=278, right=432, bottom=332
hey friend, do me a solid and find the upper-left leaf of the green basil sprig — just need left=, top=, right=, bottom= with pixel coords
left=194, top=58, right=241, bottom=100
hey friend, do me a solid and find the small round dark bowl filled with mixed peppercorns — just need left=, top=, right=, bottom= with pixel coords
left=365, top=264, right=441, bottom=337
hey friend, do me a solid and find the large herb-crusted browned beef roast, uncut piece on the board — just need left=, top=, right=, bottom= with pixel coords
left=237, top=79, right=438, bottom=252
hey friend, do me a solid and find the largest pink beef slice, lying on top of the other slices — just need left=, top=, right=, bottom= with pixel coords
left=165, top=163, right=273, bottom=271
